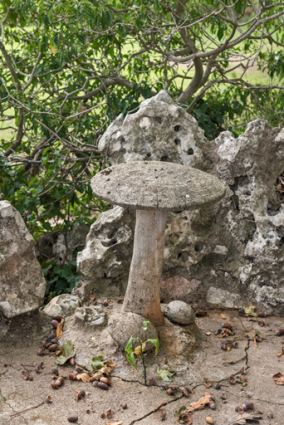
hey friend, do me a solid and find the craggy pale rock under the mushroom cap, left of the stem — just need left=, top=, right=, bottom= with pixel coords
left=74, top=206, right=135, bottom=299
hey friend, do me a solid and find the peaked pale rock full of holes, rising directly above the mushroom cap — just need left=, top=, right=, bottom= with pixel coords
left=99, top=90, right=206, bottom=166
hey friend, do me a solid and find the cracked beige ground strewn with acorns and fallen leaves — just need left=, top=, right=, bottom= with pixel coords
left=0, top=309, right=284, bottom=425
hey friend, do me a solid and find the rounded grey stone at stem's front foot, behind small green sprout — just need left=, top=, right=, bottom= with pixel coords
left=108, top=312, right=158, bottom=348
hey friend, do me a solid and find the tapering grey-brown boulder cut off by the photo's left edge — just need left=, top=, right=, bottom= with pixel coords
left=0, top=201, right=46, bottom=319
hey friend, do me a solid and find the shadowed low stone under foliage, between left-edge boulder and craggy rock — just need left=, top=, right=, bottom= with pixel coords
left=35, top=223, right=90, bottom=266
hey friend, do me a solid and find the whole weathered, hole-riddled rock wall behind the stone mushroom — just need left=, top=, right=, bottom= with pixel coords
left=77, top=92, right=284, bottom=314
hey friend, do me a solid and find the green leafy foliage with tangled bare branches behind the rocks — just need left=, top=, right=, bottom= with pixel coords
left=0, top=0, right=284, bottom=292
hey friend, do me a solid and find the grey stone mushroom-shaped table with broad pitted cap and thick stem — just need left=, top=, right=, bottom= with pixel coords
left=91, top=161, right=225, bottom=326
